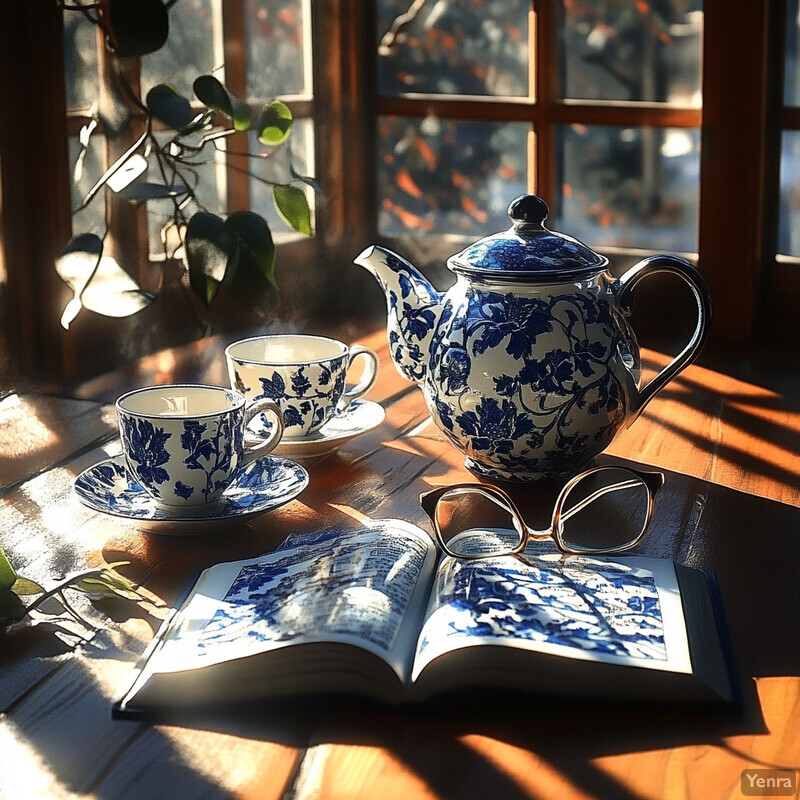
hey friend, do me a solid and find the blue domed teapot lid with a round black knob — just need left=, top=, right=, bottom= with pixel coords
left=447, top=194, right=608, bottom=281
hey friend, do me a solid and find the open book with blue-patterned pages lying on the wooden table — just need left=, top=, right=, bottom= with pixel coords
left=114, top=519, right=738, bottom=717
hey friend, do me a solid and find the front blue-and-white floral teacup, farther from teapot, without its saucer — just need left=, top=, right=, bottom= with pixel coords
left=116, top=384, right=283, bottom=509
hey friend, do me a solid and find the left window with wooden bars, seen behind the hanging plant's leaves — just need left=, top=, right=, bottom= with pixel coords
left=64, top=0, right=314, bottom=304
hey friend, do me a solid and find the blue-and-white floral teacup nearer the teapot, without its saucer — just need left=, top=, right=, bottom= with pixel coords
left=225, top=334, right=378, bottom=439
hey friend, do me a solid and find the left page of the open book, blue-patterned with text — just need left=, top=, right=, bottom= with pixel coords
left=140, top=520, right=435, bottom=672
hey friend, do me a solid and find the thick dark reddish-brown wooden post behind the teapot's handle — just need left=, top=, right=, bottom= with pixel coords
left=698, top=0, right=775, bottom=342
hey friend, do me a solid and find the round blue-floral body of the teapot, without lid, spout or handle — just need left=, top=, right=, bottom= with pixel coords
left=423, top=288, right=636, bottom=480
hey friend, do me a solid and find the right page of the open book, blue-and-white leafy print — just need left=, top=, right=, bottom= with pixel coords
left=413, top=532, right=691, bottom=679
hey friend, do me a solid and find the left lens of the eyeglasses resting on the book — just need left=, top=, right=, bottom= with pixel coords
left=434, top=489, right=522, bottom=558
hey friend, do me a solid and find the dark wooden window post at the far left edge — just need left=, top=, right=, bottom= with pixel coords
left=0, top=2, right=73, bottom=388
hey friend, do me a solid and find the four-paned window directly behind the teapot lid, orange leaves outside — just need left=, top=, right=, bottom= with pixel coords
left=379, top=0, right=703, bottom=252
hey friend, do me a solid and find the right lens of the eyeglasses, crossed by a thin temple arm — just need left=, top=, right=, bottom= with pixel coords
left=557, top=468, right=650, bottom=552
